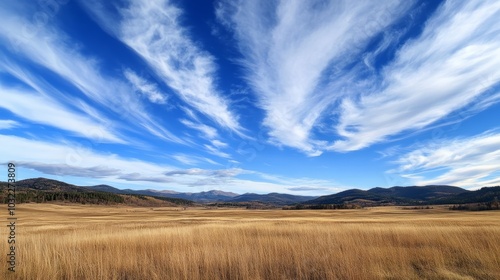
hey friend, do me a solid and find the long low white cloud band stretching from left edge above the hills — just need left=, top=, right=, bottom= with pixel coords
left=0, top=134, right=342, bottom=194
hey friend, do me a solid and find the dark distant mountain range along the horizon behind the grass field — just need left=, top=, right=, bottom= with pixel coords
left=0, top=178, right=500, bottom=206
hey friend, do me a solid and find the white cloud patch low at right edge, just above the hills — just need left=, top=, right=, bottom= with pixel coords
left=393, top=132, right=500, bottom=188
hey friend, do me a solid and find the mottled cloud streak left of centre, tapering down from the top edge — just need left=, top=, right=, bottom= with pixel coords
left=82, top=0, right=243, bottom=134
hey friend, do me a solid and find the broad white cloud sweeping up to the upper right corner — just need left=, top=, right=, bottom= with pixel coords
left=330, top=1, right=500, bottom=151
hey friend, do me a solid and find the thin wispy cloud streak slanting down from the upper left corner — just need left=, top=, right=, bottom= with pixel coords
left=0, top=4, right=183, bottom=143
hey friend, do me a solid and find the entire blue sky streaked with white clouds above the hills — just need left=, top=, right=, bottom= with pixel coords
left=0, top=0, right=500, bottom=195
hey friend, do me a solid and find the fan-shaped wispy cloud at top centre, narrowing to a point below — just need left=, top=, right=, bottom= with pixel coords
left=216, top=1, right=412, bottom=156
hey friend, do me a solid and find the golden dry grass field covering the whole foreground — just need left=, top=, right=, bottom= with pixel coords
left=0, top=204, right=500, bottom=280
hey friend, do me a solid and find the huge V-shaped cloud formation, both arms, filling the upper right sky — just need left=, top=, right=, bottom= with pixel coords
left=216, top=0, right=500, bottom=156
